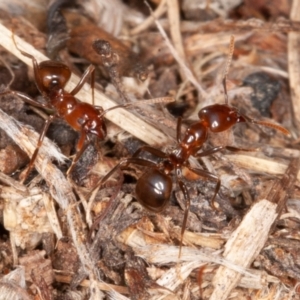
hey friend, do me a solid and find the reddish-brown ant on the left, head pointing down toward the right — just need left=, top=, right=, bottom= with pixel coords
left=0, top=34, right=173, bottom=183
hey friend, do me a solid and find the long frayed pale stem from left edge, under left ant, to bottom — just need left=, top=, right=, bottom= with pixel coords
left=0, top=110, right=112, bottom=299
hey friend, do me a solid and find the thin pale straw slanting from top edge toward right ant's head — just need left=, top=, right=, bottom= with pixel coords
left=145, top=2, right=207, bottom=99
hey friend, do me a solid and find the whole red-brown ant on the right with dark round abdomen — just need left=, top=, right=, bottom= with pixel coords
left=90, top=38, right=289, bottom=256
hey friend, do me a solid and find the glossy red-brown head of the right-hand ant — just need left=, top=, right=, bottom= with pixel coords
left=198, top=104, right=246, bottom=132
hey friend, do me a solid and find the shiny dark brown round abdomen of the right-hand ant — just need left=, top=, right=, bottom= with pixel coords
left=135, top=169, right=172, bottom=212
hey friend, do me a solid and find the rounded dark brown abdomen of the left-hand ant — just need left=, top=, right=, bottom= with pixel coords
left=35, top=60, right=71, bottom=93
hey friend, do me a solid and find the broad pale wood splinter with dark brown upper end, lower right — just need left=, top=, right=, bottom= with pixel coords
left=210, top=158, right=299, bottom=300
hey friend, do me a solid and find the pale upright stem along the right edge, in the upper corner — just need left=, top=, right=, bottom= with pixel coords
left=288, top=0, right=300, bottom=132
